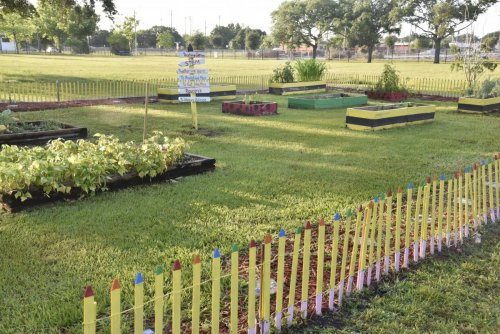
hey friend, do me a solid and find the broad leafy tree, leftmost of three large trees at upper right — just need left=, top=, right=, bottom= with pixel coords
left=271, top=0, right=338, bottom=58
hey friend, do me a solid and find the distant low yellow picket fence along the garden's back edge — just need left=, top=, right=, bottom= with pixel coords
left=0, top=73, right=466, bottom=103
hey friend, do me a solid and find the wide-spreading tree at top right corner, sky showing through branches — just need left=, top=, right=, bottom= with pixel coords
left=395, top=0, right=498, bottom=64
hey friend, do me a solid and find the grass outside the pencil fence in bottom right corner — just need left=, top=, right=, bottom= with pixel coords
left=293, top=223, right=500, bottom=334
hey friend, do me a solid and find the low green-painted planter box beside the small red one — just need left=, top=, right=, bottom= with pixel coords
left=288, top=93, right=368, bottom=109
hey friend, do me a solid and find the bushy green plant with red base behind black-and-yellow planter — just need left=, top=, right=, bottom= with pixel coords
left=366, top=64, right=408, bottom=102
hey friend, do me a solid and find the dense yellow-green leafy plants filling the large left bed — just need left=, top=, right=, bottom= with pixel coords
left=0, top=132, right=187, bottom=201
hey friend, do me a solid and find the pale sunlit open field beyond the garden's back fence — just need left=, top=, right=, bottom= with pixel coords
left=0, top=54, right=500, bottom=82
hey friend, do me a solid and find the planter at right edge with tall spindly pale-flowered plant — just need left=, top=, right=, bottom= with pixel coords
left=451, top=37, right=500, bottom=113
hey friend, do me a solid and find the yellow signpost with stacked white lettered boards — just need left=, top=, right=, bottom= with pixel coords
left=177, top=51, right=210, bottom=130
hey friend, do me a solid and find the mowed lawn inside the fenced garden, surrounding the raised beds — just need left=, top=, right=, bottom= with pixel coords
left=0, top=96, right=500, bottom=333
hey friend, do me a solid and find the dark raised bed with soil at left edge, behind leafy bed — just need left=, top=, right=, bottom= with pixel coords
left=0, top=121, right=87, bottom=145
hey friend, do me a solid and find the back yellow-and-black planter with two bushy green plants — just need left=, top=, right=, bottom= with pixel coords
left=269, top=59, right=326, bottom=95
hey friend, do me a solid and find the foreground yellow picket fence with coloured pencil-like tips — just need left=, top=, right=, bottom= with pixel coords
left=83, top=154, right=500, bottom=334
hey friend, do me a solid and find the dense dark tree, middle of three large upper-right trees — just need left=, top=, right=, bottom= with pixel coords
left=345, top=0, right=399, bottom=63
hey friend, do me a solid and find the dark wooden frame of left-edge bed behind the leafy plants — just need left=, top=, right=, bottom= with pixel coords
left=0, top=121, right=87, bottom=145
